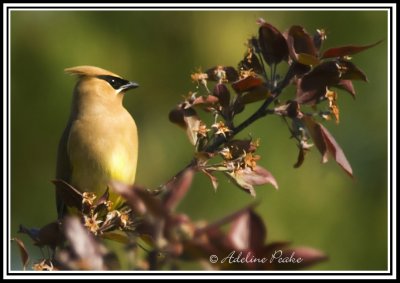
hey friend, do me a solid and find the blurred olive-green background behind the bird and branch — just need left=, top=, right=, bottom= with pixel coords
left=11, top=11, right=388, bottom=270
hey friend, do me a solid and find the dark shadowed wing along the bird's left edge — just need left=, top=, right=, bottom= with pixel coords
left=56, top=121, right=72, bottom=219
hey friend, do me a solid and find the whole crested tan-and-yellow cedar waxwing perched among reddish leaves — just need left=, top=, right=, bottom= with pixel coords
left=56, top=66, right=138, bottom=218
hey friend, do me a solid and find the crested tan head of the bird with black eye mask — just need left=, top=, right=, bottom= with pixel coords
left=65, top=66, right=139, bottom=112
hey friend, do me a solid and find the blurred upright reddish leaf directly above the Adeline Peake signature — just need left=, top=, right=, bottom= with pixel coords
left=228, top=209, right=267, bottom=251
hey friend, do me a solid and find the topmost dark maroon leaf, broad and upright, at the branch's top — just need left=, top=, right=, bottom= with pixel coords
left=258, top=20, right=289, bottom=65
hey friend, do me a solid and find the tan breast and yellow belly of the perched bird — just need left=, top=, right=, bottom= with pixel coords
left=68, top=112, right=138, bottom=207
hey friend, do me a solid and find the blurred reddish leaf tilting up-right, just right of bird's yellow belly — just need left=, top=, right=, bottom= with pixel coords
left=163, top=167, right=194, bottom=210
